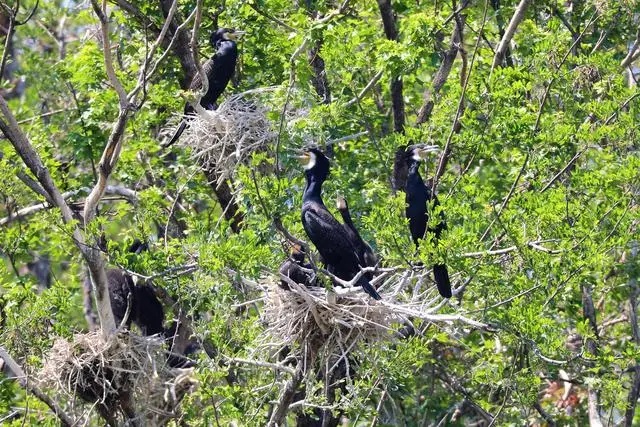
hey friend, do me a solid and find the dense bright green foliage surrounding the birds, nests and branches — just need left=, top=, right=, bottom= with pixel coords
left=0, top=0, right=640, bottom=425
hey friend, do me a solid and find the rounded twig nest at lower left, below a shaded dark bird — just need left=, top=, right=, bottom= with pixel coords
left=38, top=331, right=196, bottom=425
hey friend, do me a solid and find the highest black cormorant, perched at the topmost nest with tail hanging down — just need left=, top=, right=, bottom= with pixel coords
left=165, top=28, right=244, bottom=147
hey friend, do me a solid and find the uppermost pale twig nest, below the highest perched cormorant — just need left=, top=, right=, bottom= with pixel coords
left=181, top=88, right=276, bottom=184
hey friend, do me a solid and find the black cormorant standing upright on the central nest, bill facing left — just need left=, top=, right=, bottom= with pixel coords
left=300, top=148, right=381, bottom=299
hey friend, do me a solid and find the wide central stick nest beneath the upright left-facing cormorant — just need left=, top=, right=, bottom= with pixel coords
left=262, top=268, right=487, bottom=358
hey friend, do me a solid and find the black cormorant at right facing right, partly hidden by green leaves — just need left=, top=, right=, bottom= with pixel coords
left=405, top=144, right=451, bottom=298
